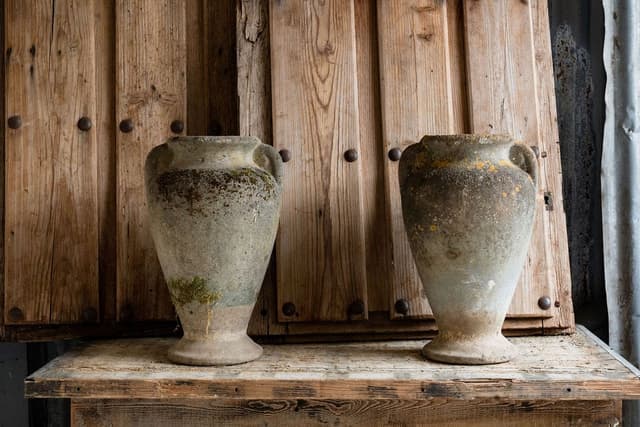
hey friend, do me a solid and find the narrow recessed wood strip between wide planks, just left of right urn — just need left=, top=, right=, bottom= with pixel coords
left=354, top=0, right=391, bottom=311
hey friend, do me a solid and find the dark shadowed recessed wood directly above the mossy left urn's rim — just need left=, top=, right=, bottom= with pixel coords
left=186, top=0, right=238, bottom=135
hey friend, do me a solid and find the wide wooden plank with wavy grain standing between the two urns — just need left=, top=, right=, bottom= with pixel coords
left=269, top=0, right=367, bottom=321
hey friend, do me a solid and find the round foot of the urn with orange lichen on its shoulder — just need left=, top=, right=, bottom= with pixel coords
left=422, top=334, right=518, bottom=365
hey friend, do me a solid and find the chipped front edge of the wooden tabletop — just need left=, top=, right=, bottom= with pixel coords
left=25, top=371, right=640, bottom=400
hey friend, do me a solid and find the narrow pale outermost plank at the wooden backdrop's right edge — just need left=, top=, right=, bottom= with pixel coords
left=530, top=0, right=575, bottom=331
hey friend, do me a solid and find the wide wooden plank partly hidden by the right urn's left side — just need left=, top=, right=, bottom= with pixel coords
left=377, top=0, right=464, bottom=317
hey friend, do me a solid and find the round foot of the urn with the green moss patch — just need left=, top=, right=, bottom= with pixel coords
left=168, top=333, right=262, bottom=366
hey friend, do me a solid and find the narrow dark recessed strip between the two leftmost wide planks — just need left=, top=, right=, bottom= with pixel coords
left=94, top=0, right=118, bottom=321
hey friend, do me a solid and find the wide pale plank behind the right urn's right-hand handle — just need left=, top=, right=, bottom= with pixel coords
left=464, top=0, right=552, bottom=317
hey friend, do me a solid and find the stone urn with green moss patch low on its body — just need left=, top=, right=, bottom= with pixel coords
left=145, top=136, right=282, bottom=365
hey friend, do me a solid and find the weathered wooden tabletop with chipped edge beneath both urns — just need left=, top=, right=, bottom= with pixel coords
left=25, top=327, right=640, bottom=400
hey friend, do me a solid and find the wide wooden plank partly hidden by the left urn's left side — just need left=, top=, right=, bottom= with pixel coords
left=116, top=0, right=187, bottom=321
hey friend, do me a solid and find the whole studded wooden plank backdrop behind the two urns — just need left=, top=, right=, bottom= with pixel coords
left=0, top=0, right=573, bottom=340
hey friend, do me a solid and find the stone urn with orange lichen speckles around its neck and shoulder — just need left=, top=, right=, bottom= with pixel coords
left=399, top=135, right=537, bottom=364
